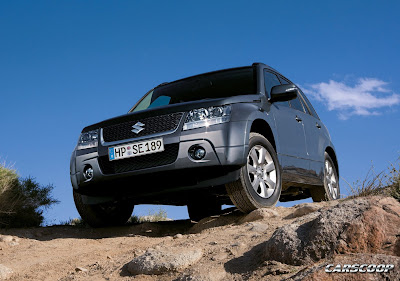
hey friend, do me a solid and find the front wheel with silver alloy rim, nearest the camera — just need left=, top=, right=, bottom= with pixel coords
left=225, top=133, right=282, bottom=213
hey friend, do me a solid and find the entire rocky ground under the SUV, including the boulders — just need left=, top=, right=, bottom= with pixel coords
left=0, top=197, right=400, bottom=281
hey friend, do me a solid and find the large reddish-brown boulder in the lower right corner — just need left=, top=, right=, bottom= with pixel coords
left=265, top=196, right=400, bottom=265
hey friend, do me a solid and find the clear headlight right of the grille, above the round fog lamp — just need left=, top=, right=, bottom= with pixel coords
left=183, top=105, right=231, bottom=131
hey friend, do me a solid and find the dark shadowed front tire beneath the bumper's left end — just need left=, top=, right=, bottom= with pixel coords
left=73, top=190, right=134, bottom=227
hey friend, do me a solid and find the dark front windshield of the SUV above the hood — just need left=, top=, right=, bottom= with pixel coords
left=129, top=67, right=256, bottom=112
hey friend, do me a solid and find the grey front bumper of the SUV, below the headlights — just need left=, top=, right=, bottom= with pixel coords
left=70, top=121, right=248, bottom=197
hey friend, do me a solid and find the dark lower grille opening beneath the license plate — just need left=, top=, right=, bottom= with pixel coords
left=99, top=143, right=179, bottom=175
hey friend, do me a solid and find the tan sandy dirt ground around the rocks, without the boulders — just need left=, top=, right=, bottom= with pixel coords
left=0, top=197, right=396, bottom=281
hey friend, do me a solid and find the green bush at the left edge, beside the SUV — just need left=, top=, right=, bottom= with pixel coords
left=0, top=164, right=58, bottom=227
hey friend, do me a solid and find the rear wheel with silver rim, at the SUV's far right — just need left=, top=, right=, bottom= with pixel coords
left=311, top=152, right=340, bottom=202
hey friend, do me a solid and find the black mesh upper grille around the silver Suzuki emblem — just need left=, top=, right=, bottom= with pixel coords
left=103, top=112, right=183, bottom=142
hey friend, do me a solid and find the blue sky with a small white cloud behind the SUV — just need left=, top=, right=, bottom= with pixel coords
left=0, top=0, right=400, bottom=224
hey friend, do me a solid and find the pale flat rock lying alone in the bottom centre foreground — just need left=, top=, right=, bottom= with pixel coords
left=128, top=247, right=203, bottom=274
